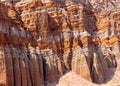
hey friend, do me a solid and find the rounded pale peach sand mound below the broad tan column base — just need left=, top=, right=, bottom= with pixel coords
left=57, top=72, right=97, bottom=86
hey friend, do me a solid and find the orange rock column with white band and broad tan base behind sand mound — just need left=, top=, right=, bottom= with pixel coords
left=71, top=5, right=92, bottom=81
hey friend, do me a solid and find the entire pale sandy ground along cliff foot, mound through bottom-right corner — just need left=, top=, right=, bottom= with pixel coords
left=56, top=69, right=120, bottom=86
